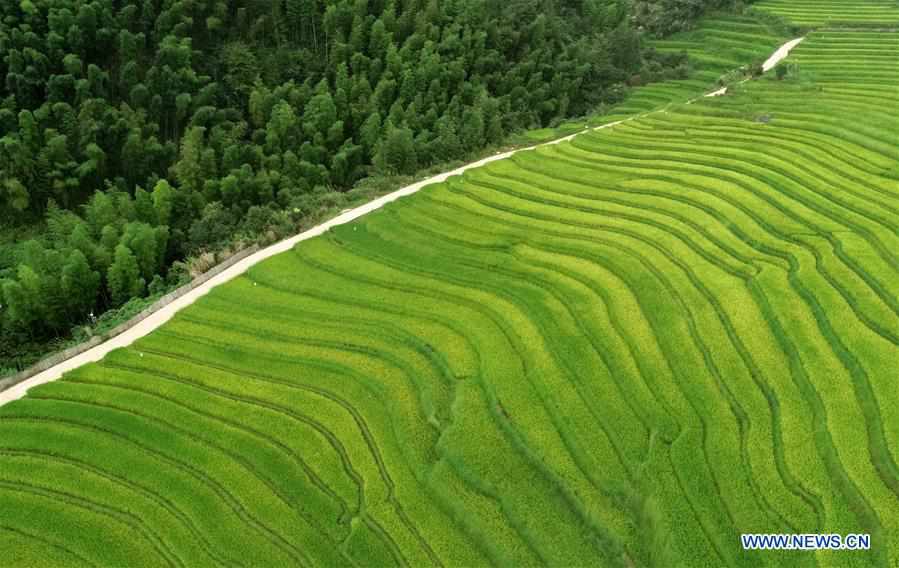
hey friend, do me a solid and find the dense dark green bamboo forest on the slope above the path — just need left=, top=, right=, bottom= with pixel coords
left=0, top=0, right=732, bottom=364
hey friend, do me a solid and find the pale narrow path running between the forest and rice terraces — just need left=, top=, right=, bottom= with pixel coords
left=0, top=34, right=805, bottom=406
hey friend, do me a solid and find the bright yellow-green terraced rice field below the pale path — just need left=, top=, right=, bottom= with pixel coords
left=0, top=0, right=899, bottom=567
